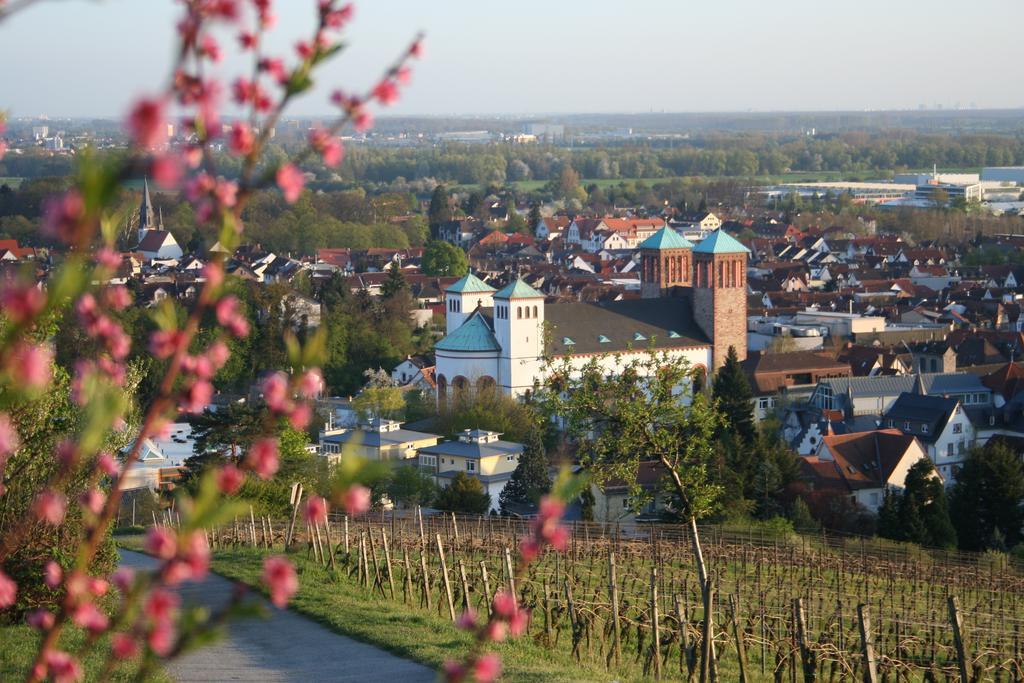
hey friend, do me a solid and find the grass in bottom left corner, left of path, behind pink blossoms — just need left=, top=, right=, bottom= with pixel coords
left=0, top=626, right=171, bottom=683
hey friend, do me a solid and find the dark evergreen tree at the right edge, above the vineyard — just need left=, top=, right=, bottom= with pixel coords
left=950, top=444, right=1024, bottom=550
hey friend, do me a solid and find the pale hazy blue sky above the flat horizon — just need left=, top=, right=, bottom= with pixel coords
left=0, top=0, right=1024, bottom=118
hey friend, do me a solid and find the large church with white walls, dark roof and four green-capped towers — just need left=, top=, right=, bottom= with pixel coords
left=434, top=227, right=750, bottom=400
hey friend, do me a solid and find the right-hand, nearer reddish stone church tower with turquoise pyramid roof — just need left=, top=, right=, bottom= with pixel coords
left=692, top=229, right=750, bottom=372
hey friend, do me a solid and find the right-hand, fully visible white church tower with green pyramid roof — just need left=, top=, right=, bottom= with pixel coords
left=495, top=280, right=544, bottom=396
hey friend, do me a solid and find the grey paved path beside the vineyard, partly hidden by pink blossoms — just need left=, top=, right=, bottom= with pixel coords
left=121, top=550, right=437, bottom=683
